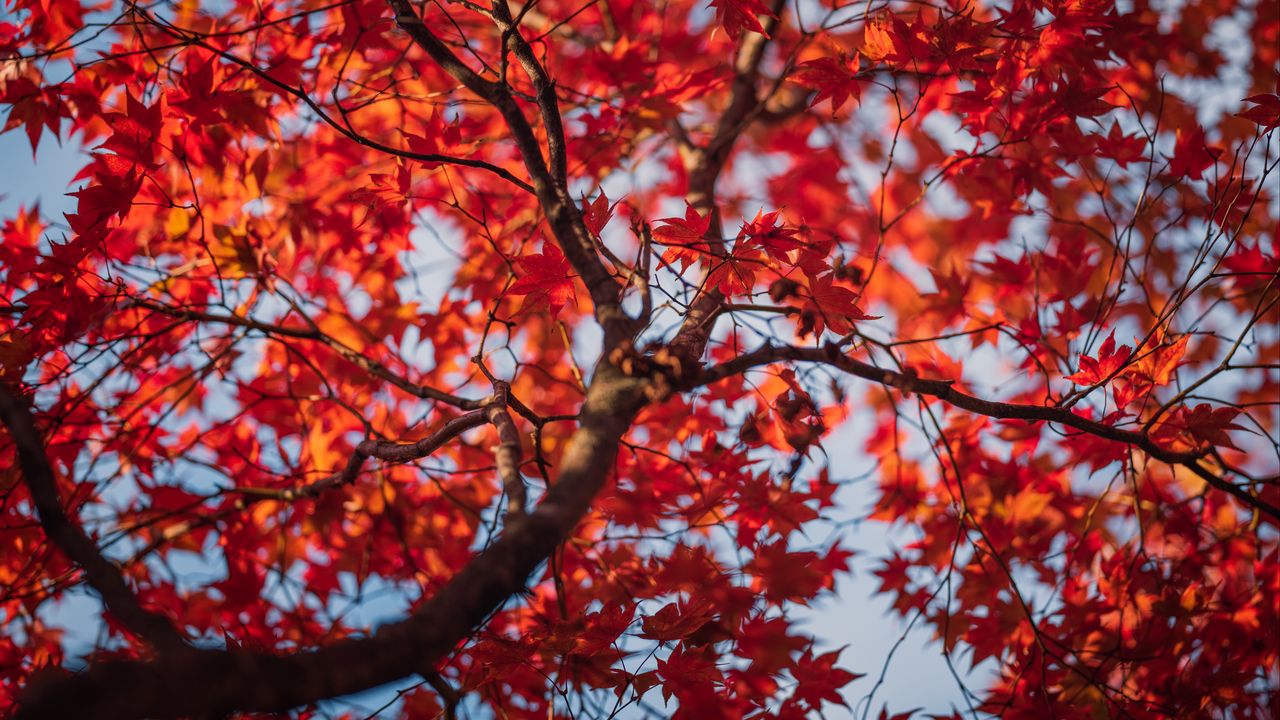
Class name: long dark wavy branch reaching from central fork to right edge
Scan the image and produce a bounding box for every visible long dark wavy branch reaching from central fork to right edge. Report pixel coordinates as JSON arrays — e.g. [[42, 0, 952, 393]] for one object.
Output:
[[685, 345, 1280, 521]]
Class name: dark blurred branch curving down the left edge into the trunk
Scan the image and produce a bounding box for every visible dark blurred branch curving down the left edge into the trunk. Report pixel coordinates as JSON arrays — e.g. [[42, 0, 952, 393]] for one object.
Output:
[[0, 387, 191, 657]]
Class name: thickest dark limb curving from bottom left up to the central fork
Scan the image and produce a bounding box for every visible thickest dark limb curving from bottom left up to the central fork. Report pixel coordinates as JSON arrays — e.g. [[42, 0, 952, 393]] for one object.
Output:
[[15, 364, 645, 720]]
